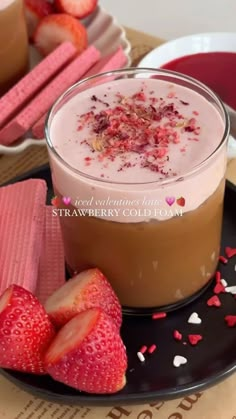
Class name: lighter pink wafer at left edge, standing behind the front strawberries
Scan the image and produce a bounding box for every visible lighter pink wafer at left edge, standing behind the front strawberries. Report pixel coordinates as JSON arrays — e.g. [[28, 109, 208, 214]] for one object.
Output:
[[0, 179, 46, 294]]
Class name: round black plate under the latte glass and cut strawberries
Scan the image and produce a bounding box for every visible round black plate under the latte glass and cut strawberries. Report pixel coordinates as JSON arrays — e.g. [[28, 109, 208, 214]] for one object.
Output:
[[1, 167, 236, 406]]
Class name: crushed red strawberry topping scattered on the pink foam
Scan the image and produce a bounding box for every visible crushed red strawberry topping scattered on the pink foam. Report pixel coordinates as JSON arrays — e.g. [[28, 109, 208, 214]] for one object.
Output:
[[77, 89, 200, 178]]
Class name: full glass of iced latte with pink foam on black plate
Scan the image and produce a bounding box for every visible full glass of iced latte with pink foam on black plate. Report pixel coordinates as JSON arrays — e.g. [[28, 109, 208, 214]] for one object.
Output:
[[46, 69, 228, 312]]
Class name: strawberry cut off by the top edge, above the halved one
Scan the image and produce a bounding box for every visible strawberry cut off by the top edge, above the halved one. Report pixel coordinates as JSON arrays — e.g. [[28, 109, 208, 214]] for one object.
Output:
[[55, 0, 98, 19]]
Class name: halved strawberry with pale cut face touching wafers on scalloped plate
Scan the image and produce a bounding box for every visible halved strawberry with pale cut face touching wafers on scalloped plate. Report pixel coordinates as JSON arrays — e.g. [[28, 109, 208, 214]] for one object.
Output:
[[34, 14, 88, 55]]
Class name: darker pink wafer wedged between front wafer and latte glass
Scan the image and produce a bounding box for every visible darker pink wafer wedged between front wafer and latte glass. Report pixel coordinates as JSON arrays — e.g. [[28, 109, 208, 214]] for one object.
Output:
[[36, 206, 65, 304]]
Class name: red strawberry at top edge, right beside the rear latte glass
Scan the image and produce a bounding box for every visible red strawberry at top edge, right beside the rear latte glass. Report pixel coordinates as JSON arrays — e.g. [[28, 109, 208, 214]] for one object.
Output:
[[24, 0, 54, 39]]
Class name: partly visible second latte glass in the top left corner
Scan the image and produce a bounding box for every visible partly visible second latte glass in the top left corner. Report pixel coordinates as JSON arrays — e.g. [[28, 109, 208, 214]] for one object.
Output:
[[0, 0, 29, 95]]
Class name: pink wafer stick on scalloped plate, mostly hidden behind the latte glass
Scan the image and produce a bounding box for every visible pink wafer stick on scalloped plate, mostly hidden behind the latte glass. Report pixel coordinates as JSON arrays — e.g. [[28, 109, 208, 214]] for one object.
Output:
[[32, 47, 127, 139]]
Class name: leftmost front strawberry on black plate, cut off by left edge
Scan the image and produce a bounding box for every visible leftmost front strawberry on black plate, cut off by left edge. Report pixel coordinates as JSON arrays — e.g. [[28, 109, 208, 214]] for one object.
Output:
[[0, 285, 55, 374]]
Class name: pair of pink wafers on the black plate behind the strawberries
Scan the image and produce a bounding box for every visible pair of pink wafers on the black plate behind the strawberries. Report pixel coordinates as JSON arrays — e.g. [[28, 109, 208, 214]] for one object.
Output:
[[0, 179, 65, 302]]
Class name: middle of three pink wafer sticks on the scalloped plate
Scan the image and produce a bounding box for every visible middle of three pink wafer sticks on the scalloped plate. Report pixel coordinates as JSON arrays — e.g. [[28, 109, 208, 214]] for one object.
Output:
[[0, 46, 100, 145]]
